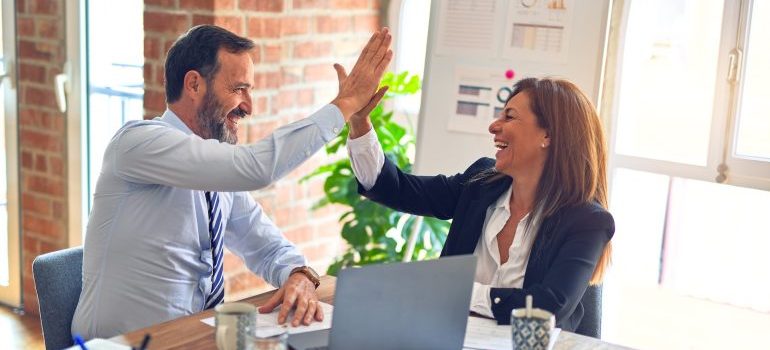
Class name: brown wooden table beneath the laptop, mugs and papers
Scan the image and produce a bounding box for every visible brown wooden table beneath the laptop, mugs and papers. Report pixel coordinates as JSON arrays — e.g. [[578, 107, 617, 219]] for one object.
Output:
[[110, 276, 628, 350]]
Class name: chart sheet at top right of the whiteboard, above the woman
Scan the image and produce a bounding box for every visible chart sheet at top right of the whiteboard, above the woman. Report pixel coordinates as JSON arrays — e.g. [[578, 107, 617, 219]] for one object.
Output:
[[501, 0, 578, 63]]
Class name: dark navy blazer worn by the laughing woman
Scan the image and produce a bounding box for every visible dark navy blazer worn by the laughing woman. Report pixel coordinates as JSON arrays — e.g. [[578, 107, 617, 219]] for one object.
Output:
[[358, 157, 615, 331]]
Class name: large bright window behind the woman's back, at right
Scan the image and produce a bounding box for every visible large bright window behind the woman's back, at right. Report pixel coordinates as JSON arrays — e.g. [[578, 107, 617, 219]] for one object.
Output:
[[602, 0, 770, 349]]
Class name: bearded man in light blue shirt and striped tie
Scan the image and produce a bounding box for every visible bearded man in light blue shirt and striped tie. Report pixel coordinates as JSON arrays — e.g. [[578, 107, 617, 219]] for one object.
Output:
[[72, 25, 392, 338]]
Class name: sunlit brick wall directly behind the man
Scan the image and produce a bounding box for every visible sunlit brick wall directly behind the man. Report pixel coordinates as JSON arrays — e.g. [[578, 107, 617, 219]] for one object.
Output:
[[144, 0, 380, 300]]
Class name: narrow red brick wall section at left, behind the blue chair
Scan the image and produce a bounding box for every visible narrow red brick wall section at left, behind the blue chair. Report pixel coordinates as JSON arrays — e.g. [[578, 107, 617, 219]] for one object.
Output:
[[16, 0, 67, 313]]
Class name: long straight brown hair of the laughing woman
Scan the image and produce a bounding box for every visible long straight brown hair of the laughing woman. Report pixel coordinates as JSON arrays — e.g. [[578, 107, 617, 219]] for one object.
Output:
[[474, 78, 612, 285]]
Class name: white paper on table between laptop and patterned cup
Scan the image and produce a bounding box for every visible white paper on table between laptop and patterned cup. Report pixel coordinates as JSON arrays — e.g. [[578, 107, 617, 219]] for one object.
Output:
[[463, 316, 561, 350]]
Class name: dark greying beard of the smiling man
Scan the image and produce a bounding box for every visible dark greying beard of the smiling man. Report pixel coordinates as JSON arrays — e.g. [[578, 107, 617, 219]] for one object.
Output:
[[197, 90, 246, 145]]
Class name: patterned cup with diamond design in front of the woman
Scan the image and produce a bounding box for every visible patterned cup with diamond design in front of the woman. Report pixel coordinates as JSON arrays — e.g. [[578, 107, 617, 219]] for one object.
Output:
[[511, 308, 556, 350]]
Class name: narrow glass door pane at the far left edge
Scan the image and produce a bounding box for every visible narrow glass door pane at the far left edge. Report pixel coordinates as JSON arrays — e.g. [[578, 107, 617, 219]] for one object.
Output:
[[0, 1, 21, 307]]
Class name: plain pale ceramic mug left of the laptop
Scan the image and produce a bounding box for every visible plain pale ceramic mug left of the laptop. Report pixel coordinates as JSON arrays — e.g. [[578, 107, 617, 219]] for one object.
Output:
[[214, 303, 257, 350]]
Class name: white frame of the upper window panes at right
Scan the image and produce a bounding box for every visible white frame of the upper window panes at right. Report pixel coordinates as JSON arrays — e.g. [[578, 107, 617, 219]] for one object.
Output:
[[600, 0, 770, 190]]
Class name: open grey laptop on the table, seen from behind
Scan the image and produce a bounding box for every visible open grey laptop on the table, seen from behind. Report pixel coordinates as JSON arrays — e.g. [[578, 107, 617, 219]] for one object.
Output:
[[289, 255, 476, 350]]
